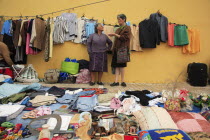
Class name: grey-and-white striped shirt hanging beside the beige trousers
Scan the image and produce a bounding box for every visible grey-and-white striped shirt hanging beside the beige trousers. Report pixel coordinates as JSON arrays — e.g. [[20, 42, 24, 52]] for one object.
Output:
[[53, 16, 68, 44]]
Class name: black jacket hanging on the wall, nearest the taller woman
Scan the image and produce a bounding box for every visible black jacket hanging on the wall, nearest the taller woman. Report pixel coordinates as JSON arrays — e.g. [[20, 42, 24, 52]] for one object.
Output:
[[139, 19, 160, 48]]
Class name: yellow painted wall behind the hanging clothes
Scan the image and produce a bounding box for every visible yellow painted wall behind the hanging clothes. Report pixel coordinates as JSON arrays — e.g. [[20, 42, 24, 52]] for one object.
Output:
[[0, 0, 210, 83]]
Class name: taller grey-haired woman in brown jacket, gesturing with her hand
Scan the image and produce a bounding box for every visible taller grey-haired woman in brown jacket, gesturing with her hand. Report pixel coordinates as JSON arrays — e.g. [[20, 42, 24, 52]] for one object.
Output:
[[109, 14, 131, 87]]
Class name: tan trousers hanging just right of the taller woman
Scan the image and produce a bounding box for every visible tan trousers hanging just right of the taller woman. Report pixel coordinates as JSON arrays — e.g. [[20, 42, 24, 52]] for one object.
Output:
[[130, 25, 143, 51]]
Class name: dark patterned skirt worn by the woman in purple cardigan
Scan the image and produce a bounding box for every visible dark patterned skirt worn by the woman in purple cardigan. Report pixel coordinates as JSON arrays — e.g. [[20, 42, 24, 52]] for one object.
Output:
[[89, 52, 108, 72]]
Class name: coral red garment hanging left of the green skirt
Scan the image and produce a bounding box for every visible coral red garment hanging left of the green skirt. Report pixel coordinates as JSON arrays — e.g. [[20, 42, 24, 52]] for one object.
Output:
[[168, 23, 179, 47]]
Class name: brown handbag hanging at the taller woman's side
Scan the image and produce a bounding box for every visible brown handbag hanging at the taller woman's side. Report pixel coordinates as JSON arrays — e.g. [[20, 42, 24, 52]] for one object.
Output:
[[117, 46, 130, 63]]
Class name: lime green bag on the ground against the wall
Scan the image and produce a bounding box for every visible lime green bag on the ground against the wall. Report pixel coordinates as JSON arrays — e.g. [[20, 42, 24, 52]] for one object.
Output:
[[61, 61, 79, 74]]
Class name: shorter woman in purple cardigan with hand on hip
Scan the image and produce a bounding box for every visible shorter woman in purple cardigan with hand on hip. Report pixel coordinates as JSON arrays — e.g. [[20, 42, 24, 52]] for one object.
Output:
[[87, 23, 112, 86]]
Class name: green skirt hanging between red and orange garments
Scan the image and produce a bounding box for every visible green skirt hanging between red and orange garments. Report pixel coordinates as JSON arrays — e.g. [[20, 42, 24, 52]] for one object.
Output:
[[174, 25, 189, 46]]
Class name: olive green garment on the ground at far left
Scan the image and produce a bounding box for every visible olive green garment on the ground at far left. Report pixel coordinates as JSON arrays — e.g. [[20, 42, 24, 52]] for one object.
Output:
[[0, 93, 26, 104]]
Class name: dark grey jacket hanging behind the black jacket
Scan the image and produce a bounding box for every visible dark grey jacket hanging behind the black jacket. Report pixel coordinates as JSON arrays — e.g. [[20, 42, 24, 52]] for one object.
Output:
[[150, 13, 168, 42]]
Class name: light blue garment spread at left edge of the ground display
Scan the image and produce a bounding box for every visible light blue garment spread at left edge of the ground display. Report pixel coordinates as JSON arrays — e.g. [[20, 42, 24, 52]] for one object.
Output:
[[0, 83, 41, 98]]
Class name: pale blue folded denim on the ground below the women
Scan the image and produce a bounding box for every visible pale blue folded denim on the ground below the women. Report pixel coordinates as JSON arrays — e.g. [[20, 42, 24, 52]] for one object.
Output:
[[77, 95, 98, 111]]
